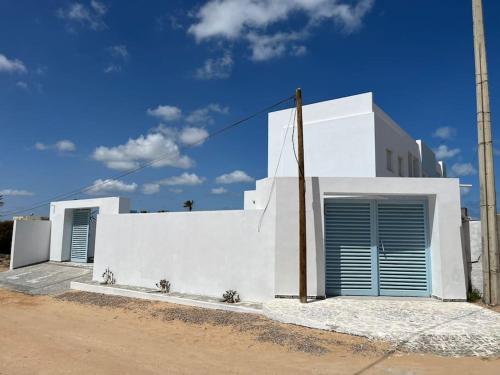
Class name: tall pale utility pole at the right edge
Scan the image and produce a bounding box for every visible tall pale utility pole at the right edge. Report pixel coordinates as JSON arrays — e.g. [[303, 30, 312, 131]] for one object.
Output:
[[472, 0, 500, 305]]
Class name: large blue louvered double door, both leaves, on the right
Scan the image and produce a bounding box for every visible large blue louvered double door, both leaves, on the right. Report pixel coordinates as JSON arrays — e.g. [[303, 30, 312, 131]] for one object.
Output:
[[325, 199, 430, 296]]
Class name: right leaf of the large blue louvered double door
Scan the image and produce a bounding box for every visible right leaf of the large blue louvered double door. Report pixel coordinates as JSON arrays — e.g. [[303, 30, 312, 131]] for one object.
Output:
[[377, 201, 430, 296]]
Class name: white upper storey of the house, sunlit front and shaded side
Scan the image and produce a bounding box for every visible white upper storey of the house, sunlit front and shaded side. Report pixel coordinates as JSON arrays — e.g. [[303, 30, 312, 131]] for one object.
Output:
[[268, 93, 442, 181]]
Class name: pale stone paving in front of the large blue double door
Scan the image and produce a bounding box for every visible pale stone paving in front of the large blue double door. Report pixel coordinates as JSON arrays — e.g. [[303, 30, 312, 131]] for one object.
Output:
[[264, 297, 500, 356]]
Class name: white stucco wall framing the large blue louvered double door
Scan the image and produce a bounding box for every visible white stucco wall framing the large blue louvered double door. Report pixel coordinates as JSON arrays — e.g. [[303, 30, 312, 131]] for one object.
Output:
[[264, 177, 466, 300]]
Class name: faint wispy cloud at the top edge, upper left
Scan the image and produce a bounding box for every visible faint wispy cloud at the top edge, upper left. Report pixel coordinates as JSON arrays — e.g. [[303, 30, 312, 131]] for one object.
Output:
[[57, 0, 108, 30]]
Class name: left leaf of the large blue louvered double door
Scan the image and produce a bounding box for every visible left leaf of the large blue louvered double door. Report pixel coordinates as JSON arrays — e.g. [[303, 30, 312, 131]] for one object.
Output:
[[325, 199, 378, 295]]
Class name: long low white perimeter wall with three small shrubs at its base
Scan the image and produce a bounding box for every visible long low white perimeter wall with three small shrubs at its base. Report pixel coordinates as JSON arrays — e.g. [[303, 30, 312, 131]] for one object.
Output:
[[94, 209, 275, 301]]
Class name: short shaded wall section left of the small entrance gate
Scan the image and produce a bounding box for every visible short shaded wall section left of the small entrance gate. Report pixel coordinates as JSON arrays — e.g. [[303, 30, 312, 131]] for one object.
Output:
[[10, 220, 50, 270]]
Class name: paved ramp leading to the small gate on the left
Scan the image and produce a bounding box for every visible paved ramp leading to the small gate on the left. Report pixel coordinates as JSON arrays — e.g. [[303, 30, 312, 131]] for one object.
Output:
[[0, 262, 92, 295]]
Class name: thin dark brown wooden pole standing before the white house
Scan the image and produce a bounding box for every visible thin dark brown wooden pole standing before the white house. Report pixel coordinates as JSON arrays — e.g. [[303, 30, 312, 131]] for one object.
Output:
[[295, 89, 307, 303]]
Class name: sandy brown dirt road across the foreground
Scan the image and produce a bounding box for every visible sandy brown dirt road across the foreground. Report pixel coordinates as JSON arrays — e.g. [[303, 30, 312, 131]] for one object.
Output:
[[0, 289, 500, 375]]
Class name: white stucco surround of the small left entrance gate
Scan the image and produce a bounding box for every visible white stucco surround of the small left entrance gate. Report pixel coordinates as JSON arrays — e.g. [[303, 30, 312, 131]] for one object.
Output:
[[50, 197, 130, 262]]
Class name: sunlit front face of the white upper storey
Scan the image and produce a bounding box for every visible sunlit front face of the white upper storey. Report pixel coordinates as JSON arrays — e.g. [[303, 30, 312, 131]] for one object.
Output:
[[268, 93, 375, 177]]
